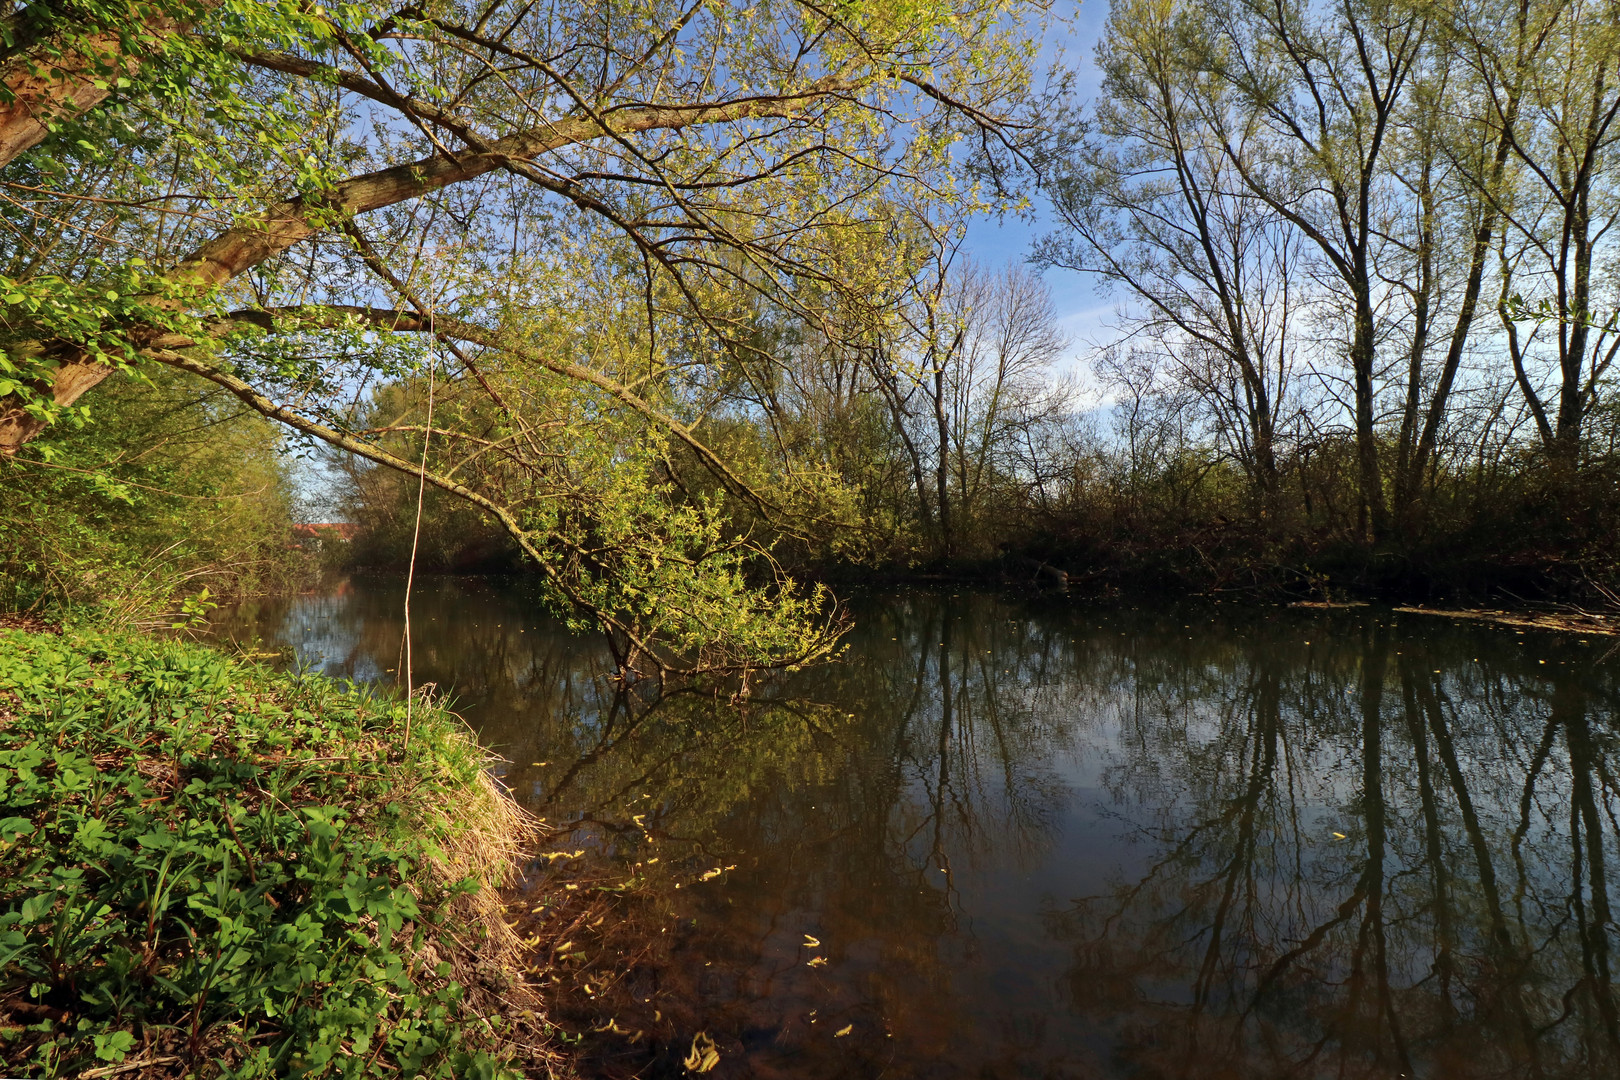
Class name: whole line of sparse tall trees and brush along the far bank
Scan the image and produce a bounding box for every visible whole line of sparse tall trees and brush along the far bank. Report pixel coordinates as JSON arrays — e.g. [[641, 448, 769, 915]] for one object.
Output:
[[322, 0, 1620, 602]]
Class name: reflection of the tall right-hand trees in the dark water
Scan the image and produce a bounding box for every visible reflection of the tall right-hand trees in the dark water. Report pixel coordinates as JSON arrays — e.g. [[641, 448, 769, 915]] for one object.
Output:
[[1051, 619, 1620, 1077]]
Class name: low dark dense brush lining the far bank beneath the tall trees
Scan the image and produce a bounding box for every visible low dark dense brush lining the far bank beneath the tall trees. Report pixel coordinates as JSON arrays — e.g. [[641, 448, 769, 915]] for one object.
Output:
[[328, 418, 1620, 607]]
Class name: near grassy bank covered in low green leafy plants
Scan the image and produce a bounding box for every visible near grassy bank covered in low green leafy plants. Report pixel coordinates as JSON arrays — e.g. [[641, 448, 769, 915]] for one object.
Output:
[[0, 630, 551, 1077]]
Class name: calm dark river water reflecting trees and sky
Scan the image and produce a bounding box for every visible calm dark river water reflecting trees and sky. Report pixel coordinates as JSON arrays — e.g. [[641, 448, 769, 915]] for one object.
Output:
[[222, 580, 1620, 1078]]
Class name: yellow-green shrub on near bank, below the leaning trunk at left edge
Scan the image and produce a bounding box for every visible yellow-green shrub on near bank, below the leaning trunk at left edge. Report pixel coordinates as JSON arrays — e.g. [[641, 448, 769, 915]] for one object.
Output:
[[0, 371, 292, 623]]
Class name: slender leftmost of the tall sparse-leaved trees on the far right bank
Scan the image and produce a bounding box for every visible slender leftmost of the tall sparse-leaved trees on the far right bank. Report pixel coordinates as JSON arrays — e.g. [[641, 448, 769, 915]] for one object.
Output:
[[1038, 3, 1306, 512]]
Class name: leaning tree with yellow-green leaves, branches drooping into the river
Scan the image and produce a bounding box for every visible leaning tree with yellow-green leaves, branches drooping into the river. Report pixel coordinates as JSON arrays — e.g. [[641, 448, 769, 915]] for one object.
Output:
[[0, 0, 1029, 670]]
